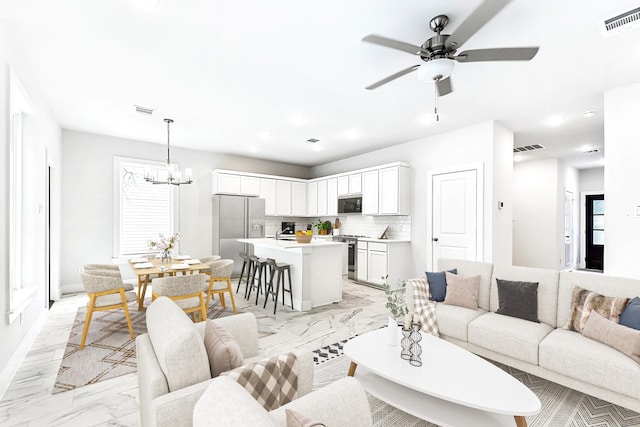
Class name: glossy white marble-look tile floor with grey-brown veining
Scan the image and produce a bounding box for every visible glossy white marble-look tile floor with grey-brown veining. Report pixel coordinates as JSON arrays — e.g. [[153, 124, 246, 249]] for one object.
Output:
[[0, 279, 387, 427]]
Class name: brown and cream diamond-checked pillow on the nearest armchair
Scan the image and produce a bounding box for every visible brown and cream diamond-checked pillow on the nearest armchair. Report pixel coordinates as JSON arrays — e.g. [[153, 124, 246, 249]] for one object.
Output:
[[220, 353, 298, 411]]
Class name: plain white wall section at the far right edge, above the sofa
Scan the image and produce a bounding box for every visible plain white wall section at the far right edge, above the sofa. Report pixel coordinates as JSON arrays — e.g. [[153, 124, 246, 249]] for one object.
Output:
[[604, 83, 640, 278]]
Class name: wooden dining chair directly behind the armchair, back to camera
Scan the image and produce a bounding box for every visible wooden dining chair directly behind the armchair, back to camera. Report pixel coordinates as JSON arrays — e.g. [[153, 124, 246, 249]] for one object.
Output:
[[151, 274, 207, 322]]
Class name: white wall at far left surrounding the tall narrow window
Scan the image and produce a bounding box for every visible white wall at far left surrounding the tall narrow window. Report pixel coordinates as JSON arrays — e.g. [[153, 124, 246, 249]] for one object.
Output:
[[0, 25, 60, 369]]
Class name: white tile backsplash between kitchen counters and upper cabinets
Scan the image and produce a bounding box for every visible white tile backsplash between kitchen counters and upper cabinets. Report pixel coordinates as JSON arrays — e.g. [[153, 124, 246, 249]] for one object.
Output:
[[265, 215, 411, 240]]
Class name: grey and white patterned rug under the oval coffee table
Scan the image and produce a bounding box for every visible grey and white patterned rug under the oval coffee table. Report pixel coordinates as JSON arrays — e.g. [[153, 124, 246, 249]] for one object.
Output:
[[314, 341, 640, 427]]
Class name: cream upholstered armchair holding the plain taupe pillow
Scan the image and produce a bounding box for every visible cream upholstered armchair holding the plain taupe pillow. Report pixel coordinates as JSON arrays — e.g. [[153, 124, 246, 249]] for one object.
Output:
[[136, 297, 314, 427]]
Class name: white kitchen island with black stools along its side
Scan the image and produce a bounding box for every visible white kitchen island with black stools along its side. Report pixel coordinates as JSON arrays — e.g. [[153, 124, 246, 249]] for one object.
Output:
[[238, 238, 345, 311]]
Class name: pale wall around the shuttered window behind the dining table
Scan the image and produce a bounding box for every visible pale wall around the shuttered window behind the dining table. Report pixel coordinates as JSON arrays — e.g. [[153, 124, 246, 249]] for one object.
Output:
[[61, 130, 309, 293]]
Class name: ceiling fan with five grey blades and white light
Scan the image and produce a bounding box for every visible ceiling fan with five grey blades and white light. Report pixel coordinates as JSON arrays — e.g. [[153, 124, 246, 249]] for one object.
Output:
[[362, 0, 538, 99]]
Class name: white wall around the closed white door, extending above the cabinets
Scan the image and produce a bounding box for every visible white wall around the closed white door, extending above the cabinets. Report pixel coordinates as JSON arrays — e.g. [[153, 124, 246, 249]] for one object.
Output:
[[312, 122, 513, 276]]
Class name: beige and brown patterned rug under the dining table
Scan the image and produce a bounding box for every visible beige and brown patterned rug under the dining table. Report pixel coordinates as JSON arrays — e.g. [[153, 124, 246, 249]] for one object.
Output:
[[52, 298, 273, 394]]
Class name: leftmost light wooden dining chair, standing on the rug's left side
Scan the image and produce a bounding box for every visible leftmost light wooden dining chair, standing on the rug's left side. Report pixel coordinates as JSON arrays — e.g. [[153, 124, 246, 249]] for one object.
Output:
[[80, 268, 138, 350]]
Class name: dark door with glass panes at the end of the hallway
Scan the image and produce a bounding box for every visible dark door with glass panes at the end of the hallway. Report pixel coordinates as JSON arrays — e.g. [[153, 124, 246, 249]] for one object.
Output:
[[584, 194, 604, 271]]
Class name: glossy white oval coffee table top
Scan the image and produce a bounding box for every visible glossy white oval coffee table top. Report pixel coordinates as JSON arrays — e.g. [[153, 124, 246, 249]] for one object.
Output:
[[344, 328, 541, 416]]
